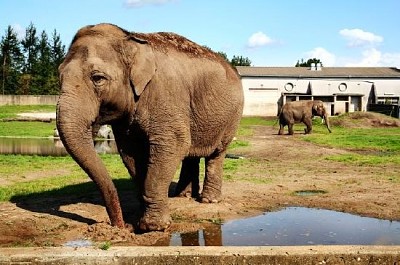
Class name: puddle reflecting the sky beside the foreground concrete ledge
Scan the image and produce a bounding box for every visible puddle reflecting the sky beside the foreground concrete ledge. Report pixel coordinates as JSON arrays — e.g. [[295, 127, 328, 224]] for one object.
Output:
[[170, 207, 400, 246]]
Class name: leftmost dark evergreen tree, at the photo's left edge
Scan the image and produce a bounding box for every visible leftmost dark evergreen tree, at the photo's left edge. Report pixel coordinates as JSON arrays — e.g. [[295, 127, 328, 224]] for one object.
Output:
[[0, 26, 24, 95]]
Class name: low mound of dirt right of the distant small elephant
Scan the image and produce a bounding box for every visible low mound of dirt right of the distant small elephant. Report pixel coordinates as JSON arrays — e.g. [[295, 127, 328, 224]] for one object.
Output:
[[330, 112, 400, 128]]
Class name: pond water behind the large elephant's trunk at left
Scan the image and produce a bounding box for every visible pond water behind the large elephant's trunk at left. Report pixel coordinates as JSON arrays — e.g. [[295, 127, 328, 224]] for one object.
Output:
[[0, 138, 117, 156]]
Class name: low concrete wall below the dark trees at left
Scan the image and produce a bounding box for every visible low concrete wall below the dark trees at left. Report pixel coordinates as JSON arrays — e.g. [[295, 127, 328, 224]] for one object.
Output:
[[0, 95, 58, 106]]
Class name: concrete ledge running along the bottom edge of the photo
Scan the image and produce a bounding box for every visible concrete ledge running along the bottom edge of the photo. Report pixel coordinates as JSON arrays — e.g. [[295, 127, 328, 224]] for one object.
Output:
[[0, 245, 400, 265]]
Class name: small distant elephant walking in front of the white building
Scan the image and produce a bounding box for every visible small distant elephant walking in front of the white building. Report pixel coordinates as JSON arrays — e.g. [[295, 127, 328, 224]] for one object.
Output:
[[278, 100, 332, 135]]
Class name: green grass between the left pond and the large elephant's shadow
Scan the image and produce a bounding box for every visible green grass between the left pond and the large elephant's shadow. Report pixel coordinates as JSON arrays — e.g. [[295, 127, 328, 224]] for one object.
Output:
[[0, 155, 130, 201]]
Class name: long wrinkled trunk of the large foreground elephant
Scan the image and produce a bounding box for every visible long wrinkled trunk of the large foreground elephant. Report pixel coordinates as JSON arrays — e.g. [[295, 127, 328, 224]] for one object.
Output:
[[57, 93, 125, 228]]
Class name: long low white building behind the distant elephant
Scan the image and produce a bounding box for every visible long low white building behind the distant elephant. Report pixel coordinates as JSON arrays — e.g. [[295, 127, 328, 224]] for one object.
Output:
[[237, 65, 400, 116]]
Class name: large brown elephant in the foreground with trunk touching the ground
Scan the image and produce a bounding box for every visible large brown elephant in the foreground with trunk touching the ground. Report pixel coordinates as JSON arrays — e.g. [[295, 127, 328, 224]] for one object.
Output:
[[57, 24, 243, 230]]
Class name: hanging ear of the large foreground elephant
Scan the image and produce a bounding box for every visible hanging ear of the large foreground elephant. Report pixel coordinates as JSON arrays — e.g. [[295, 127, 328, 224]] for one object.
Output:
[[128, 35, 156, 96]]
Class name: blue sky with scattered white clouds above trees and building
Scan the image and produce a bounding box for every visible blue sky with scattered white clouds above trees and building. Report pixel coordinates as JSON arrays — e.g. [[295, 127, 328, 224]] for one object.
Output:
[[0, 0, 400, 68]]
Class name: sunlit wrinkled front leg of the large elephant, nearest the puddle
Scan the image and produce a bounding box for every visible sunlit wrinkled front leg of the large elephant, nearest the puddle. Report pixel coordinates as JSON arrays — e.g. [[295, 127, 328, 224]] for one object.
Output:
[[139, 154, 180, 231]]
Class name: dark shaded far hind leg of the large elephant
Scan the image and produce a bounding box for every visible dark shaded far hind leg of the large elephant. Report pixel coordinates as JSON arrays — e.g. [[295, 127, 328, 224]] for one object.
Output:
[[174, 157, 200, 198]]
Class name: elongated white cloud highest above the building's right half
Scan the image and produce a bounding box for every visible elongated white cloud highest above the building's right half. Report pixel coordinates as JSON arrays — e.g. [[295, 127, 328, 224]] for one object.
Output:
[[339, 29, 383, 47]]
